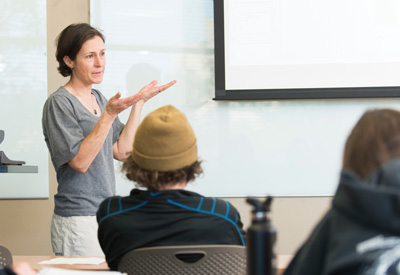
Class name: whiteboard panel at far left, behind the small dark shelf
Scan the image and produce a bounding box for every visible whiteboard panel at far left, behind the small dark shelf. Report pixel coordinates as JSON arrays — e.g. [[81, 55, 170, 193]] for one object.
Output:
[[0, 0, 49, 199]]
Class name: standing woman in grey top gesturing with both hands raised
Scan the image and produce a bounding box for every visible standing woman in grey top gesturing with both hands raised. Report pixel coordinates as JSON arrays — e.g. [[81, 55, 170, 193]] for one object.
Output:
[[42, 23, 175, 256]]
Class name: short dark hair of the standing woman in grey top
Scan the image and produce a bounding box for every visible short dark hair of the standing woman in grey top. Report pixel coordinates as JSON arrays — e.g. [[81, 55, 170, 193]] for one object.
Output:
[[56, 23, 105, 76]]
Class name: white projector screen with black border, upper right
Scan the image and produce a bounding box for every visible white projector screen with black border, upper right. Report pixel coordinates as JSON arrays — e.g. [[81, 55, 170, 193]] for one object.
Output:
[[214, 0, 400, 100]]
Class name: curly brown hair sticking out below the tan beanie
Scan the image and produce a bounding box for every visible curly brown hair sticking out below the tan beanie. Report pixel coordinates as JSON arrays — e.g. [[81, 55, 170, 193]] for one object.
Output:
[[122, 156, 203, 191]]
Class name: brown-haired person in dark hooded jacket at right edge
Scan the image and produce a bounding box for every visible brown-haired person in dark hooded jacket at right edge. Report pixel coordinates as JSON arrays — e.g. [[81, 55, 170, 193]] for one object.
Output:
[[284, 109, 400, 275]]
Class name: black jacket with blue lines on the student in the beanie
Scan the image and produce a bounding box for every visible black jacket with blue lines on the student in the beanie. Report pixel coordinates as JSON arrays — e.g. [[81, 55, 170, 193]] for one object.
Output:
[[97, 189, 245, 270]]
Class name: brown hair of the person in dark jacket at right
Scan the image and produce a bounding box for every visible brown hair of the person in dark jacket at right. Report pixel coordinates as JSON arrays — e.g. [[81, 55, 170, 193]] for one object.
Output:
[[343, 109, 400, 178]]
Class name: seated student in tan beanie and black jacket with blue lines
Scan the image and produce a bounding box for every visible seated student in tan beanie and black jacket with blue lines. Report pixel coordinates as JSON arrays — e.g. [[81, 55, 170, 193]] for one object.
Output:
[[97, 105, 245, 270]]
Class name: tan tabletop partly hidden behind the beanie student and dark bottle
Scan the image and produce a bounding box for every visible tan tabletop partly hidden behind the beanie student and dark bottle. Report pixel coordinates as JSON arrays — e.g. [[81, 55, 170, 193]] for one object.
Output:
[[13, 255, 293, 275]]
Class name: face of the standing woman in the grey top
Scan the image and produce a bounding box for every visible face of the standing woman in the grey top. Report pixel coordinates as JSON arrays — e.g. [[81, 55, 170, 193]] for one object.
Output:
[[71, 36, 106, 86]]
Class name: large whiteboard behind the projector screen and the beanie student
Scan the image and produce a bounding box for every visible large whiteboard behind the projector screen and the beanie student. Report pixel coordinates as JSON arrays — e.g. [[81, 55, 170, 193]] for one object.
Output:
[[90, 0, 400, 197]]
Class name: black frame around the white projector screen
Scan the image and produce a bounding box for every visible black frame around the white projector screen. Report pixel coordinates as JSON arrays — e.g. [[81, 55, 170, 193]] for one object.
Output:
[[213, 0, 400, 101]]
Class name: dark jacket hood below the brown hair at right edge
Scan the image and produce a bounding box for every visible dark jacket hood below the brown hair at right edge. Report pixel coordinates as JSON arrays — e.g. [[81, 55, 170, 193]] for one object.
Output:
[[332, 159, 400, 235]]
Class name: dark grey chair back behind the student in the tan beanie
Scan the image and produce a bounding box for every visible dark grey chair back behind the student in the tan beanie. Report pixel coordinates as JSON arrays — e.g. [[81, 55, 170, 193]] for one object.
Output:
[[118, 245, 247, 275]]
